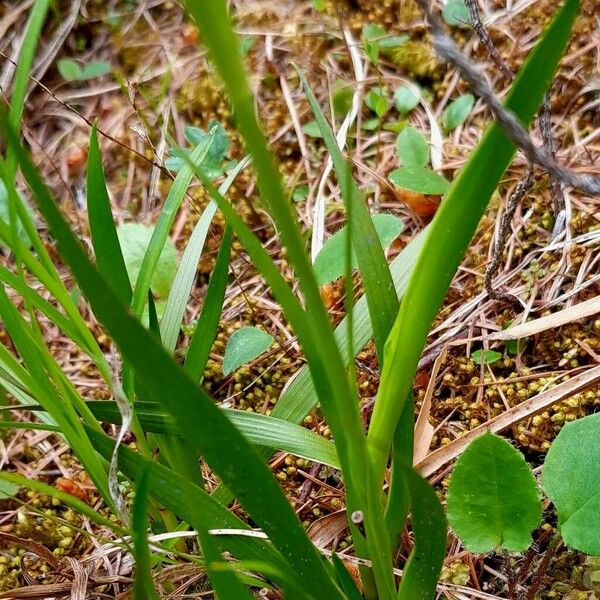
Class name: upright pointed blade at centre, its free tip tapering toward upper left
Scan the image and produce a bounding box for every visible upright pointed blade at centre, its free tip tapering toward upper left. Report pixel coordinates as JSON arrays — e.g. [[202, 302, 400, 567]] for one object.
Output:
[[296, 68, 399, 365]]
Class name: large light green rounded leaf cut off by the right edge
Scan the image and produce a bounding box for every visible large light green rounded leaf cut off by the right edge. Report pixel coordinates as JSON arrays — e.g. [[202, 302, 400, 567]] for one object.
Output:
[[542, 413, 600, 556]]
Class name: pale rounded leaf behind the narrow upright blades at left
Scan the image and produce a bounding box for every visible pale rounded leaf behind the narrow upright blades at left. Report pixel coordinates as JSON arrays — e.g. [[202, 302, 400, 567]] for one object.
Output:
[[117, 223, 177, 298]]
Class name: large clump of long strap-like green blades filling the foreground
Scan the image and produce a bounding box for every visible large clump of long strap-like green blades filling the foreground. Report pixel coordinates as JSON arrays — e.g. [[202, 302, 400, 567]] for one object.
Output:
[[0, 0, 578, 600]]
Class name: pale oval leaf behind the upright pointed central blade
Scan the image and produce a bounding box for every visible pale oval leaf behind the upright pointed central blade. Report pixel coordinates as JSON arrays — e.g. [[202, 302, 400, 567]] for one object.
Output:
[[314, 214, 404, 285]]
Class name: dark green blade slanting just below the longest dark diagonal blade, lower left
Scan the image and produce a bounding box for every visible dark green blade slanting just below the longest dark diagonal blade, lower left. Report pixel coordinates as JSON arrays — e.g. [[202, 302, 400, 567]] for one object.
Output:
[[89, 430, 301, 582]]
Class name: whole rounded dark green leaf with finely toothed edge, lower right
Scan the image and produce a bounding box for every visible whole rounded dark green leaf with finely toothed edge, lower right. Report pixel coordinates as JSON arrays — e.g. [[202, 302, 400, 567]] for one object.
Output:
[[447, 433, 542, 553]]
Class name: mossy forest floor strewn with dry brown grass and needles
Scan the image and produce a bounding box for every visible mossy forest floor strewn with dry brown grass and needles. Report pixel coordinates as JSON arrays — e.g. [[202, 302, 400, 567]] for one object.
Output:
[[0, 0, 600, 600]]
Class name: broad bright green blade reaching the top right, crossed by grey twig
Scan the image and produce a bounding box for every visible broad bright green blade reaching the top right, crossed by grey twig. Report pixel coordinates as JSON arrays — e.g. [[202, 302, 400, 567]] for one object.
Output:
[[368, 0, 579, 481]]
